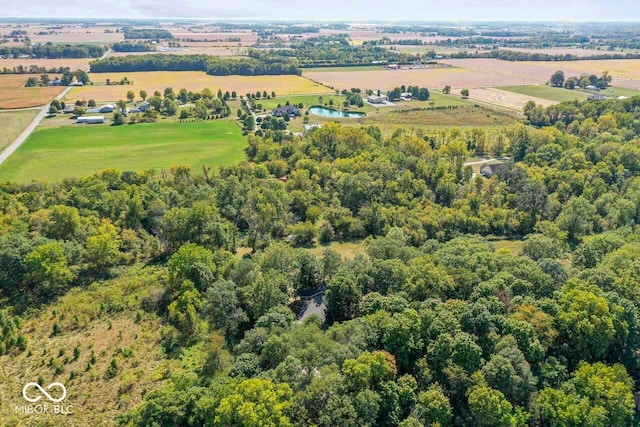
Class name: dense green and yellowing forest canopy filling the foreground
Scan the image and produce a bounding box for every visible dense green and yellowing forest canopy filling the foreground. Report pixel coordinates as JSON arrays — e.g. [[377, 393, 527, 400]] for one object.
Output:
[[0, 90, 640, 427]]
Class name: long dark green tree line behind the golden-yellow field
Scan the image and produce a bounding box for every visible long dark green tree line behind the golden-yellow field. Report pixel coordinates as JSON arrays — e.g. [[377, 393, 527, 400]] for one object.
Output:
[[89, 54, 301, 76]]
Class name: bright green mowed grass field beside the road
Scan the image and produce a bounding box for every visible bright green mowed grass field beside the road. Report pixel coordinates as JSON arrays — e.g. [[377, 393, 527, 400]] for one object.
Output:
[[0, 121, 245, 182]]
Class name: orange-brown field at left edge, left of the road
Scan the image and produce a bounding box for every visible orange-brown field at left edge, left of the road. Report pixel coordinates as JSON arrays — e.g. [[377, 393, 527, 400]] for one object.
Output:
[[0, 74, 64, 109]]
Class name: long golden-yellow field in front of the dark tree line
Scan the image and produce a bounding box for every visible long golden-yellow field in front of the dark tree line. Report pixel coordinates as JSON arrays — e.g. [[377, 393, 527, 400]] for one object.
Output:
[[67, 71, 332, 102]]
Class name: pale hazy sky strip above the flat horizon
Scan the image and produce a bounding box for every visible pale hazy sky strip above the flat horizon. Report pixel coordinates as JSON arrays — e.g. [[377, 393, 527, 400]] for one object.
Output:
[[0, 0, 640, 22]]
